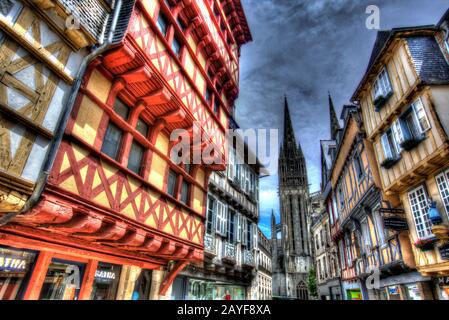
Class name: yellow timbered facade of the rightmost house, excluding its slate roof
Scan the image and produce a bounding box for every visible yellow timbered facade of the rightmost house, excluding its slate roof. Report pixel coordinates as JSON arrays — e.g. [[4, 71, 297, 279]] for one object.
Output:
[[355, 29, 449, 288]]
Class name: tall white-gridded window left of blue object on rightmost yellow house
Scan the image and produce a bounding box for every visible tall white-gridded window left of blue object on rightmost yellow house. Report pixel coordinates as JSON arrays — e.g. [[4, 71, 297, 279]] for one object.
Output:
[[408, 186, 431, 238]]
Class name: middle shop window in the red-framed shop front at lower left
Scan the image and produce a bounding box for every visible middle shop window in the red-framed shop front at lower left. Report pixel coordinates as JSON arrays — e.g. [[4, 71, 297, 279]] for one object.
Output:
[[39, 259, 85, 300]]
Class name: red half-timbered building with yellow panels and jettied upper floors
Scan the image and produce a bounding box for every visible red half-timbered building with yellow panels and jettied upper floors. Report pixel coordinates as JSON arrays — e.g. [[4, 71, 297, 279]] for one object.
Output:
[[0, 0, 251, 299]]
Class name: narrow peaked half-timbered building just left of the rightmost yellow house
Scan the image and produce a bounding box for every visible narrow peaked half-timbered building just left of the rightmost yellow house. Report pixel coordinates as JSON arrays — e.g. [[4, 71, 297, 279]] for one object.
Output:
[[329, 105, 428, 300]]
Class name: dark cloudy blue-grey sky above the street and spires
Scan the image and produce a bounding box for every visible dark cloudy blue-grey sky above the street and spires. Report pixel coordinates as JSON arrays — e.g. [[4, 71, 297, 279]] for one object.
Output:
[[236, 0, 449, 236]]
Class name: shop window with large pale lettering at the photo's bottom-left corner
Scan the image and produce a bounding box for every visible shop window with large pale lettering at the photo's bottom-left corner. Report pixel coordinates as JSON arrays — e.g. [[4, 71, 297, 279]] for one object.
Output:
[[0, 247, 36, 300]]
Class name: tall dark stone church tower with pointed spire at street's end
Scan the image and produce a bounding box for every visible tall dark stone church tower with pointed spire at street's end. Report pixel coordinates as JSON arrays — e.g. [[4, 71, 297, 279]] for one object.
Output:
[[272, 98, 312, 300]]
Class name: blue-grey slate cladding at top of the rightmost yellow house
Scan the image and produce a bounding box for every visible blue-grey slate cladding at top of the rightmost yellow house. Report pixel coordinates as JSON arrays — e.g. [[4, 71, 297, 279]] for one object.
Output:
[[406, 37, 449, 84]]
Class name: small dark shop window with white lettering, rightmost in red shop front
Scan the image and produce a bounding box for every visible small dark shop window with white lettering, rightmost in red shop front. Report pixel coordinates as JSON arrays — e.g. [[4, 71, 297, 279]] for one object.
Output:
[[90, 262, 121, 300]]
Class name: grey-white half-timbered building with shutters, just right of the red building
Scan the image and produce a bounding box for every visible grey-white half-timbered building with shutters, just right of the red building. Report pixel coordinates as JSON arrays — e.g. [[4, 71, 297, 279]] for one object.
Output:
[[173, 128, 262, 300]]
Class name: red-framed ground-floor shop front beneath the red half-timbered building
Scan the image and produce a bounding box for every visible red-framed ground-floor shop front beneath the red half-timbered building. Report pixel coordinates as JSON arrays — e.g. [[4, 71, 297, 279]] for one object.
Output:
[[0, 236, 159, 300]]
